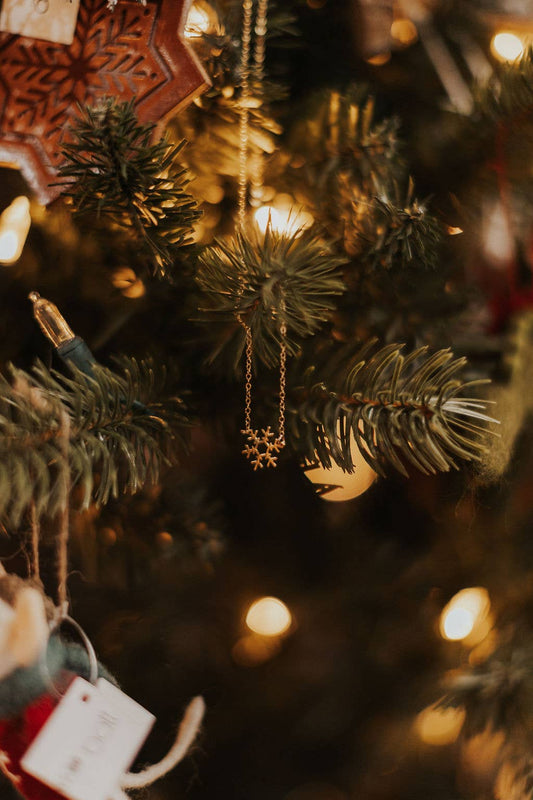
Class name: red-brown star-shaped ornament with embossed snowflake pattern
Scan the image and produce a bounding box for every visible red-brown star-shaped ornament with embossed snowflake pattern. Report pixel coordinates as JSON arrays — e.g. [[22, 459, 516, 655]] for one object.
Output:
[[0, 0, 208, 203]]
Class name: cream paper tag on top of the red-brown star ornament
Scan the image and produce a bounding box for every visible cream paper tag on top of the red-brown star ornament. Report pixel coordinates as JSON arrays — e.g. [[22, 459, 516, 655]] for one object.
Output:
[[0, 0, 80, 44]]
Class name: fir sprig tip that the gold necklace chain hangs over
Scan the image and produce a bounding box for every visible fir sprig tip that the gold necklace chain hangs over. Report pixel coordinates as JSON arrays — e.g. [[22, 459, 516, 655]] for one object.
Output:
[[197, 226, 345, 366]]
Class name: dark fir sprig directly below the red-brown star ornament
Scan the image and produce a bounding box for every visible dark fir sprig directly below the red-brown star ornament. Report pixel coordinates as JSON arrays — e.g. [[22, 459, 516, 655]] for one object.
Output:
[[60, 100, 200, 277]]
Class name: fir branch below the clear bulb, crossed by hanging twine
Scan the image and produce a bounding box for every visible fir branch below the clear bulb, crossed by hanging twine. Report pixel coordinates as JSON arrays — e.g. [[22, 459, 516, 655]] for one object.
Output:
[[0, 359, 185, 526]]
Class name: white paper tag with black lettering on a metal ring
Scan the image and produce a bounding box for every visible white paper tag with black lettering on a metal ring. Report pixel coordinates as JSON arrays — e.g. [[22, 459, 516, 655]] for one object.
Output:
[[20, 678, 155, 800]]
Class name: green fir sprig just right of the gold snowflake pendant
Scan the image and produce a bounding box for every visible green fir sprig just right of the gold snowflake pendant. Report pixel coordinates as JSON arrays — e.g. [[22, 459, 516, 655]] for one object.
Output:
[[289, 341, 490, 476]]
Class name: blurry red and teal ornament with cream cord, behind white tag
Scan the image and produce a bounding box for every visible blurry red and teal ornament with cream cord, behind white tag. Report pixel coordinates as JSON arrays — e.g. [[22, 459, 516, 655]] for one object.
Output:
[[0, 563, 205, 800]]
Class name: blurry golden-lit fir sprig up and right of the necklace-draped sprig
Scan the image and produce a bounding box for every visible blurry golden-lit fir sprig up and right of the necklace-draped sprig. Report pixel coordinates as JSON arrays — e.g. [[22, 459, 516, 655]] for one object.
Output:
[[284, 86, 442, 270]]
